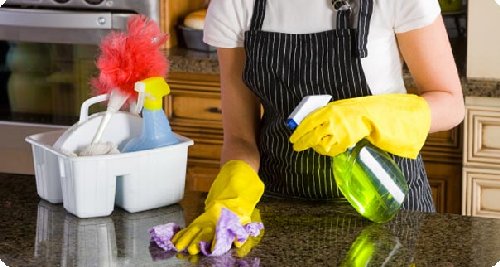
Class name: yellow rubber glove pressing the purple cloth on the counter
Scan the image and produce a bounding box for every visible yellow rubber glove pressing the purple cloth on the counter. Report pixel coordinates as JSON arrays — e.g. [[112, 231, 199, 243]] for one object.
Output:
[[172, 160, 264, 255]]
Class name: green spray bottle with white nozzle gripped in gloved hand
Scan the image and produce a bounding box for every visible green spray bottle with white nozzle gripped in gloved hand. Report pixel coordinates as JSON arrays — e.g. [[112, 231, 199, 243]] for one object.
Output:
[[287, 95, 408, 223]]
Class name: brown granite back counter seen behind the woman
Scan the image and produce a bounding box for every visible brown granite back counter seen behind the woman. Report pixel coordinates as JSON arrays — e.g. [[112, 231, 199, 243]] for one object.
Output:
[[167, 48, 500, 97]]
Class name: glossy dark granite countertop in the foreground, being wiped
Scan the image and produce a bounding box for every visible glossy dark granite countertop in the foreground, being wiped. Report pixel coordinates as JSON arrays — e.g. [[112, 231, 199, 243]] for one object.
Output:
[[0, 173, 500, 267]]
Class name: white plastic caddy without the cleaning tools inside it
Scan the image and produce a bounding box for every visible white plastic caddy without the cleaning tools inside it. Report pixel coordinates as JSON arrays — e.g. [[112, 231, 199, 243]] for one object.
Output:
[[26, 94, 193, 218]]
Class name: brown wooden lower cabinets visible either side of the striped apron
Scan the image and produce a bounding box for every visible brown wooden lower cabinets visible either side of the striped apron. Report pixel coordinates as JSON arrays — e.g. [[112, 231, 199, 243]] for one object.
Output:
[[165, 72, 462, 216]]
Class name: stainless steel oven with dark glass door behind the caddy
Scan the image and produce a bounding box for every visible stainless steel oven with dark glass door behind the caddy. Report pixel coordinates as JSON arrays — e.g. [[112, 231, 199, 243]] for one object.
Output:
[[0, 0, 161, 174]]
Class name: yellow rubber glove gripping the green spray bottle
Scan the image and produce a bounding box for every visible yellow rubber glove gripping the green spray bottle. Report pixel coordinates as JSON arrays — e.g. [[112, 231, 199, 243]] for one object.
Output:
[[290, 94, 431, 159]]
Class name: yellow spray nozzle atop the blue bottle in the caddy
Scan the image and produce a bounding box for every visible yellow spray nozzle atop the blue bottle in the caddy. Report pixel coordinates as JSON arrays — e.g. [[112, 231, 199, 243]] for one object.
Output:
[[135, 77, 170, 110]]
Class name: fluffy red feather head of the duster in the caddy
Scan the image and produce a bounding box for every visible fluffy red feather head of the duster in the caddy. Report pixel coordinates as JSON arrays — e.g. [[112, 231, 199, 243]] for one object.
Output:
[[91, 15, 169, 101]]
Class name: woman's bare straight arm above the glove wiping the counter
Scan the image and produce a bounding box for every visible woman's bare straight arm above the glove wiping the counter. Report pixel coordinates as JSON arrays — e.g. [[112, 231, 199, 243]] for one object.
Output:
[[217, 48, 260, 171]]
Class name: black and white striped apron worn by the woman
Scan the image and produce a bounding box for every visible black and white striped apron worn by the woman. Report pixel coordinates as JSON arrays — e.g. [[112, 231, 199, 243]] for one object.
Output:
[[243, 0, 434, 214]]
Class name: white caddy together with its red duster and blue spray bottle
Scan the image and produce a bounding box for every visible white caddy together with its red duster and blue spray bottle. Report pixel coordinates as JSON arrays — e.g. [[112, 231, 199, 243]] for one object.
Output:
[[26, 15, 193, 218]]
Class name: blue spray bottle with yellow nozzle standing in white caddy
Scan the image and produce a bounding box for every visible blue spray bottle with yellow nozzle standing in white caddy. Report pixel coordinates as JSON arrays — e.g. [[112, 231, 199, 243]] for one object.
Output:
[[122, 77, 180, 152]]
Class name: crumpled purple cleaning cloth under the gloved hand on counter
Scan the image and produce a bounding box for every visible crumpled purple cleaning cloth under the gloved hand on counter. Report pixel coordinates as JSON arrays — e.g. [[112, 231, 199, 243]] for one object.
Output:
[[149, 209, 264, 256]]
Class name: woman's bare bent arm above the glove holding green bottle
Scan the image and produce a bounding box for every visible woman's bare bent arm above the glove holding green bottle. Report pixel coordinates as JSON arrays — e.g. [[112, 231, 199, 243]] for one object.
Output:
[[396, 16, 465, 133]]
